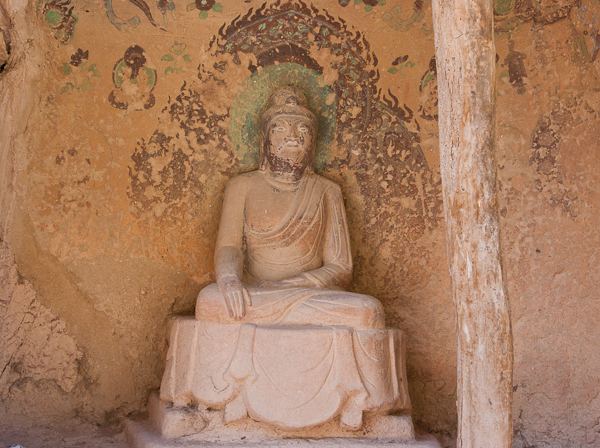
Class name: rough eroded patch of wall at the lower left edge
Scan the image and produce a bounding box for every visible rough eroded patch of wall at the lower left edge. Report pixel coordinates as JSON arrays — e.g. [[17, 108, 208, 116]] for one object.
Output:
[[0, 245, 83, 424]]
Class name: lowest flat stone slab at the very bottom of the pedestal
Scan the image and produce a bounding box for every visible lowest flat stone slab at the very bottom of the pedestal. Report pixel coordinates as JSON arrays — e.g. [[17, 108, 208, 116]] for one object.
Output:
[[125, 421, 440, 448]]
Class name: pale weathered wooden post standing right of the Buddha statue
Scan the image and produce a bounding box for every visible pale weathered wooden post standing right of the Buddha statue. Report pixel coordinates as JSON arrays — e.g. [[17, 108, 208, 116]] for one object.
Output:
[[433, 0, 513, 448]]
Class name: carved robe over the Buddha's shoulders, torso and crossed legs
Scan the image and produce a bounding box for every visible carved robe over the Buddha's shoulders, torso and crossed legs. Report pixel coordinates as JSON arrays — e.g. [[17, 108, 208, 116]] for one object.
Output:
[[196, 171, 384, 329]]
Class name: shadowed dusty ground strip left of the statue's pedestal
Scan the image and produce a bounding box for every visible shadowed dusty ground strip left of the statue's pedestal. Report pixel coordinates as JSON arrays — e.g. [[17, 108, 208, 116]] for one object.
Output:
[[0, 419, 129, 448]]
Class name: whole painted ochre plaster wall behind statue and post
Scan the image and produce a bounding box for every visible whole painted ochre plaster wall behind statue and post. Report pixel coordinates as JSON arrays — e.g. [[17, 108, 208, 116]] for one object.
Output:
[[0, 0, 600, 447]]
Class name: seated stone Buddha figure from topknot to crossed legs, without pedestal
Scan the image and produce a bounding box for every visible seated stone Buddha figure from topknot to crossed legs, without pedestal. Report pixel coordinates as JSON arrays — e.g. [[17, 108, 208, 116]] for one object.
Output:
[[196, 86, 385, 329]]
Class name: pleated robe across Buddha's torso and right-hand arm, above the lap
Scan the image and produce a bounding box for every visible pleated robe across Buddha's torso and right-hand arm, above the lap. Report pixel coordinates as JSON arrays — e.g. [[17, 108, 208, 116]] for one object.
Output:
[[241, 173, 352, 289]]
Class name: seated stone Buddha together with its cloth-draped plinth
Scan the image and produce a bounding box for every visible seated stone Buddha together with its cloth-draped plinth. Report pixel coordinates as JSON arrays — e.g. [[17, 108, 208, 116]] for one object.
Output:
[[151, 86, 412, 437]]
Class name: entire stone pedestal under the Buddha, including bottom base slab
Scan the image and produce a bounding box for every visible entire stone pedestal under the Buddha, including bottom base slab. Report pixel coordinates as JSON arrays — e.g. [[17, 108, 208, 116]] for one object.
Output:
[[127, 317, 439, 448]]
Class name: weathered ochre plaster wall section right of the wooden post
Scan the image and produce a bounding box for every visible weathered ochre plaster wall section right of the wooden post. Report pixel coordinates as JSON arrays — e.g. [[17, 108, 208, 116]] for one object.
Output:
[[498, 1, 600, 447]]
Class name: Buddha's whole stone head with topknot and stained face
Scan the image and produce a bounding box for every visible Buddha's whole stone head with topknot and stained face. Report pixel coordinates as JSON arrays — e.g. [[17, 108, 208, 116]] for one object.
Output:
[[259, 86, 317, 179]]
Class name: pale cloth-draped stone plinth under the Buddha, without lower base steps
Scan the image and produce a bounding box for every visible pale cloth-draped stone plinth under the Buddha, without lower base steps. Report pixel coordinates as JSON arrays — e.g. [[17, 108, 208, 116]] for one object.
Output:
[[160, 317, 410, 434]]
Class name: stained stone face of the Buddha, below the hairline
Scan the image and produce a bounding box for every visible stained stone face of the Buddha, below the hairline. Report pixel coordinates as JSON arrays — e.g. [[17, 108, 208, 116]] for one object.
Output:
[[266, 115, 316, 178]]
